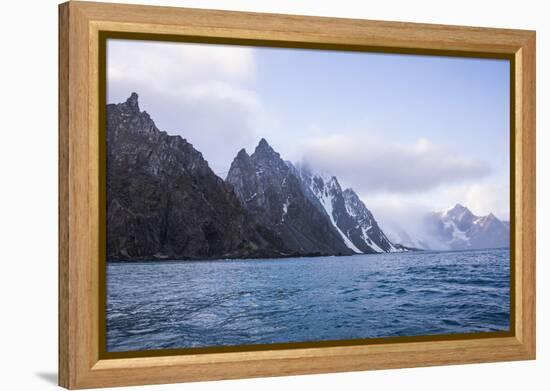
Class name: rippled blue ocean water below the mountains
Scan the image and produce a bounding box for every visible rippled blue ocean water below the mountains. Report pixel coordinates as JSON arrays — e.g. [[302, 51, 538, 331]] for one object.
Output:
[[107, 249, 510, 351]]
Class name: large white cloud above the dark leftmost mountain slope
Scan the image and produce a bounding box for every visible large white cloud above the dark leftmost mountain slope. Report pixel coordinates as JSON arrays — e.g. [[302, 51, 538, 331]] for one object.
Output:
[[107, 40, 265, 176]]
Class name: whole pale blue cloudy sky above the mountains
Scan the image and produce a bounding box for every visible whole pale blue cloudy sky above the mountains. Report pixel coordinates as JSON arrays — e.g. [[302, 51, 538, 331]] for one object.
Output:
[[107, 39, 510, 229]]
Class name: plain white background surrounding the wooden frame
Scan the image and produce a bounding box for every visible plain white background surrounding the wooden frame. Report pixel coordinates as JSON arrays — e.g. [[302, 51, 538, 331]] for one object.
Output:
[[0, 0, 550, 391]]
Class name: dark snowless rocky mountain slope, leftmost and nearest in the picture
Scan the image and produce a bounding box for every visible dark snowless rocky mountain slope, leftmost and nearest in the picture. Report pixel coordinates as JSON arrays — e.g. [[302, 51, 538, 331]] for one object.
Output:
[[107, 93, 290, 260]]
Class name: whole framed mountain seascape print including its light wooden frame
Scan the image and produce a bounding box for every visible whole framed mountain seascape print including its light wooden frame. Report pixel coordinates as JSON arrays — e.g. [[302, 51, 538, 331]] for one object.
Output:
[[59, 2, 535, 388]]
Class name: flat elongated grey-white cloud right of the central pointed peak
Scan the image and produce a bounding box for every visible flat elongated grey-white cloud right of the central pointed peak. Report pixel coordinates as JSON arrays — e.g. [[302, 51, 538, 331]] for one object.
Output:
[[304, 134, 491, 194]]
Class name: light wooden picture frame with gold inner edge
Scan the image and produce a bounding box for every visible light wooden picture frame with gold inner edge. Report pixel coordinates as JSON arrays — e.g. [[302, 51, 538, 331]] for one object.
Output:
[[59, 1, 536, 389]]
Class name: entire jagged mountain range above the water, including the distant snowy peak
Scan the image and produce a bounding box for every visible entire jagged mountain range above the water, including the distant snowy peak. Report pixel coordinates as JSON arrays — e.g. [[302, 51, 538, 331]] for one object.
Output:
[[107, 93, 509, 260]]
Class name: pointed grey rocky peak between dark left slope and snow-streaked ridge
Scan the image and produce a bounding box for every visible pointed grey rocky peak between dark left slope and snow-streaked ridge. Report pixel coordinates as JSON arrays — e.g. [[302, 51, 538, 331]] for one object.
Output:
[[226, 139, 354, 255]]
